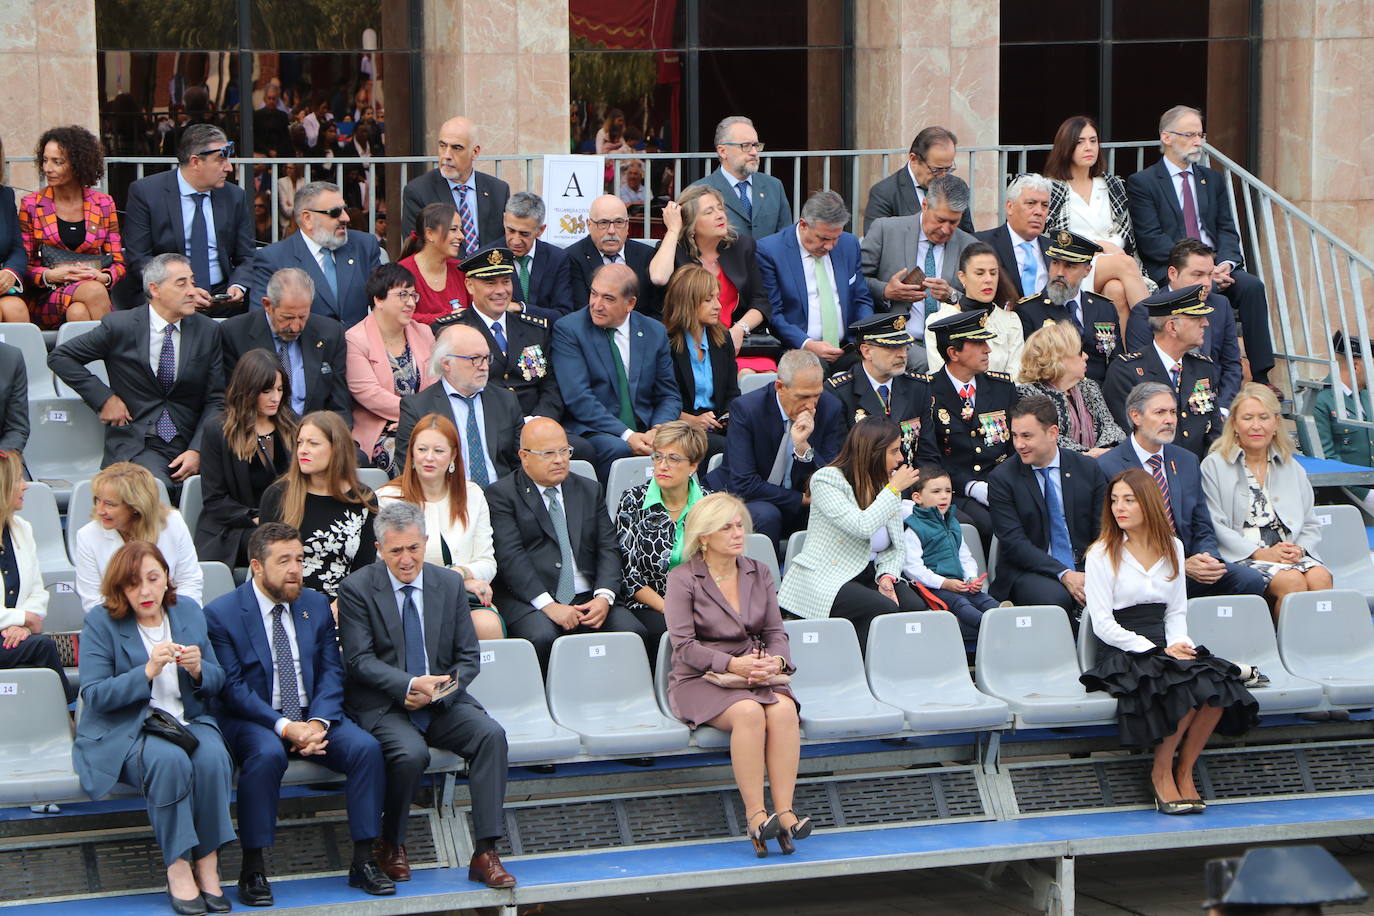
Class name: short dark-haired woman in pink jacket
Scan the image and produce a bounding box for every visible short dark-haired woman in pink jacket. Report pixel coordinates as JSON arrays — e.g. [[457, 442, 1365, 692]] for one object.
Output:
[[344, 264, 434, 477]]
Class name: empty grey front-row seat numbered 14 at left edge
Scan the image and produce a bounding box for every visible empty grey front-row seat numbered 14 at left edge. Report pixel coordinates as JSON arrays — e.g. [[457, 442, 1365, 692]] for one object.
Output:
[[0, 667, 81, 805]]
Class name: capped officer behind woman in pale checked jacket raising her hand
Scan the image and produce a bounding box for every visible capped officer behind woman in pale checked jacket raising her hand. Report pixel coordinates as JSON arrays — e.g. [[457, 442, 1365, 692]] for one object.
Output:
[[826, 314, 930, 464]]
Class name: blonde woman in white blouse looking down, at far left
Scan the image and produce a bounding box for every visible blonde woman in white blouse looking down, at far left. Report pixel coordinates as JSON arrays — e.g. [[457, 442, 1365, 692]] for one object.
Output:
[[73, 461, 203, 611]]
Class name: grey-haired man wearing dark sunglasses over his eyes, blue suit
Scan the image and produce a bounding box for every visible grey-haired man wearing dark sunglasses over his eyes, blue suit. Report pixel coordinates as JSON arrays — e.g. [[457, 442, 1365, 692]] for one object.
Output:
[[250, 181, 382, 331]]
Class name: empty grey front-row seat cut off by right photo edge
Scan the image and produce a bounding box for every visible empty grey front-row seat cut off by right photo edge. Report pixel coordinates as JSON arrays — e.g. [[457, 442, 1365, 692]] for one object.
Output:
[[1279, 589, 1374, 709]]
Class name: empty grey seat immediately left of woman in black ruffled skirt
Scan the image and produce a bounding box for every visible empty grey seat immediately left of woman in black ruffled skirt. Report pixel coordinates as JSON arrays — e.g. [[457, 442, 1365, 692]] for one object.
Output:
[[974, 604, 1116, 728]]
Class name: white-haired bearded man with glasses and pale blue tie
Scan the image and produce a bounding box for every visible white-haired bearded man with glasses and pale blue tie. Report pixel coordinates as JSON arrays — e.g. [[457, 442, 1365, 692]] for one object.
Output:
[[396, 324, 525, 489]]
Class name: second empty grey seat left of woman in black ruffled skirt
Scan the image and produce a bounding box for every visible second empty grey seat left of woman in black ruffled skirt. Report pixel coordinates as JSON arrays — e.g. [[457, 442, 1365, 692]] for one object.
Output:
[[867, 611, 1011, 732]]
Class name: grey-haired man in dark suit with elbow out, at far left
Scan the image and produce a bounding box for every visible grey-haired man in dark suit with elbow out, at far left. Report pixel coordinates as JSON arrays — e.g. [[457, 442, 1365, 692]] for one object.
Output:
[[48, 254, 224, 496]]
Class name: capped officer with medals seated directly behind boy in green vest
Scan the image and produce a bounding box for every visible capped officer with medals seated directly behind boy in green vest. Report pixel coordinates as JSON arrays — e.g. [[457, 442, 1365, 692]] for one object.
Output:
[[919, 309, 1020, 551]]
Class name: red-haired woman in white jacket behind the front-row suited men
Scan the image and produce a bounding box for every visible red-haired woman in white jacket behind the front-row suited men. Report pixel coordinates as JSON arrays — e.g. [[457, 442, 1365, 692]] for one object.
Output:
[[376, 413, 506, 640]]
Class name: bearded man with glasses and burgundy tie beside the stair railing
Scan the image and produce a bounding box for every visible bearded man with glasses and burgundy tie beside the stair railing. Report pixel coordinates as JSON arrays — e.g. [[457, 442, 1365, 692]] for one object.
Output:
[[1125, 104, 1274, 385]]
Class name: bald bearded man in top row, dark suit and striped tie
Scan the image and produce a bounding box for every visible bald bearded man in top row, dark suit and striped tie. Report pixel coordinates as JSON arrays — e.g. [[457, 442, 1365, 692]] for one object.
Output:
[[401, 117, 511, 257]]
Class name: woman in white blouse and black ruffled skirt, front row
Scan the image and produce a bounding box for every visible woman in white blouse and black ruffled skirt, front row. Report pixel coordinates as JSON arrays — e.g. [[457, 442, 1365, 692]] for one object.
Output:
[[1080, 468, 1257, 814]]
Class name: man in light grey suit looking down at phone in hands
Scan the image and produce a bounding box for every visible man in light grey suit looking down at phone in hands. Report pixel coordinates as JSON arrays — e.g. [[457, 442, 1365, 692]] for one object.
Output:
[[863, 174, 977, 372]]
